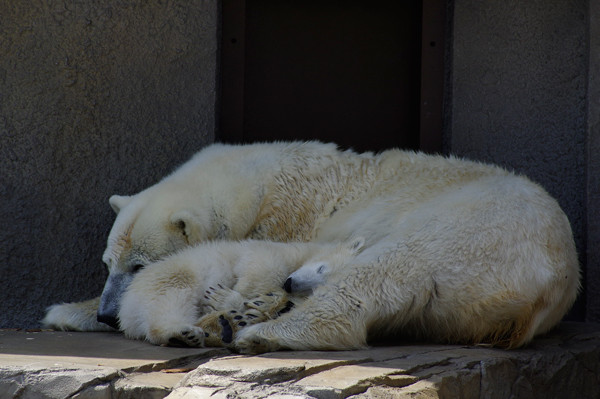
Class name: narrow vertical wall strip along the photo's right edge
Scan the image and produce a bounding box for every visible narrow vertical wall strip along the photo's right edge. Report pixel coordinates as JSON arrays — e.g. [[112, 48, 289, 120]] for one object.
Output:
[[586, 0, 600, 321]]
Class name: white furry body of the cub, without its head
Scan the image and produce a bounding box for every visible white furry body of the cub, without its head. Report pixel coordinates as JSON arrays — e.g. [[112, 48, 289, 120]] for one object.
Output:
[[119, 241, 343, 344]]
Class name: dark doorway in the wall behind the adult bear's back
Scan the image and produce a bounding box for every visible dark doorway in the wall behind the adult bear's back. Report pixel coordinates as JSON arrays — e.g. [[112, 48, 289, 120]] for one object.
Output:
[[218, 0, 443, 151]]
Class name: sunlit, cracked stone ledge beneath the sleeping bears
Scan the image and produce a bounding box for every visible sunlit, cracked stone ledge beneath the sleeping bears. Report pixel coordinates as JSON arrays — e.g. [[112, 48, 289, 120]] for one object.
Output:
[[0, 322, 600, 399]]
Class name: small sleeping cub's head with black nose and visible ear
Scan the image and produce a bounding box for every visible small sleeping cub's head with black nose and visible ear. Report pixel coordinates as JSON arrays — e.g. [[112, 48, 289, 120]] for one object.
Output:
[[283, 237, 365, 293]]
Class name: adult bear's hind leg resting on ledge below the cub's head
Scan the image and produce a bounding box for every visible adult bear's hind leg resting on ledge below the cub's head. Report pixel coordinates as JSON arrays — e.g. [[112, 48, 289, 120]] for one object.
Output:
[[234, 287, 371, 354]]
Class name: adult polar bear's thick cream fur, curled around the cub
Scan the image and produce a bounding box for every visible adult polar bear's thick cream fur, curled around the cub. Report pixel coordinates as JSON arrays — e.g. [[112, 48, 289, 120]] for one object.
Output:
[[45, 142, 579, 352]]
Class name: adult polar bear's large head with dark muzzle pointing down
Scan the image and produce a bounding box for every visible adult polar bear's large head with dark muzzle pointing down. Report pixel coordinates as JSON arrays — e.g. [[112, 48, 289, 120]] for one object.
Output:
[[97, 190, 212, 328]]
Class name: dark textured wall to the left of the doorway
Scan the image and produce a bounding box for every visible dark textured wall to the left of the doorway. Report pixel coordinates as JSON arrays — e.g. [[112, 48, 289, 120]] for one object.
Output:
[[0, 0, 218, 327]]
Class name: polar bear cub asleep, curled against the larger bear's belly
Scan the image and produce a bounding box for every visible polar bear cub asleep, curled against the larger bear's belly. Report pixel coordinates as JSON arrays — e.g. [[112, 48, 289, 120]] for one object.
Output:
[[118, 239, 363, 346]]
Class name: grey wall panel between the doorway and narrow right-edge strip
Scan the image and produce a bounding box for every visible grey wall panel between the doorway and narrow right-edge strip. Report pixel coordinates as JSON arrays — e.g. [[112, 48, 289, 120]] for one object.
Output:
[[449, 0, 588, 318]]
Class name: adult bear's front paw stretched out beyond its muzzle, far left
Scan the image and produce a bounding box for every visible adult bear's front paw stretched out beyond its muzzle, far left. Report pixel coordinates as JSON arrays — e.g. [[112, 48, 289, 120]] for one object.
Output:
[[41, 297, 114, 331]]
